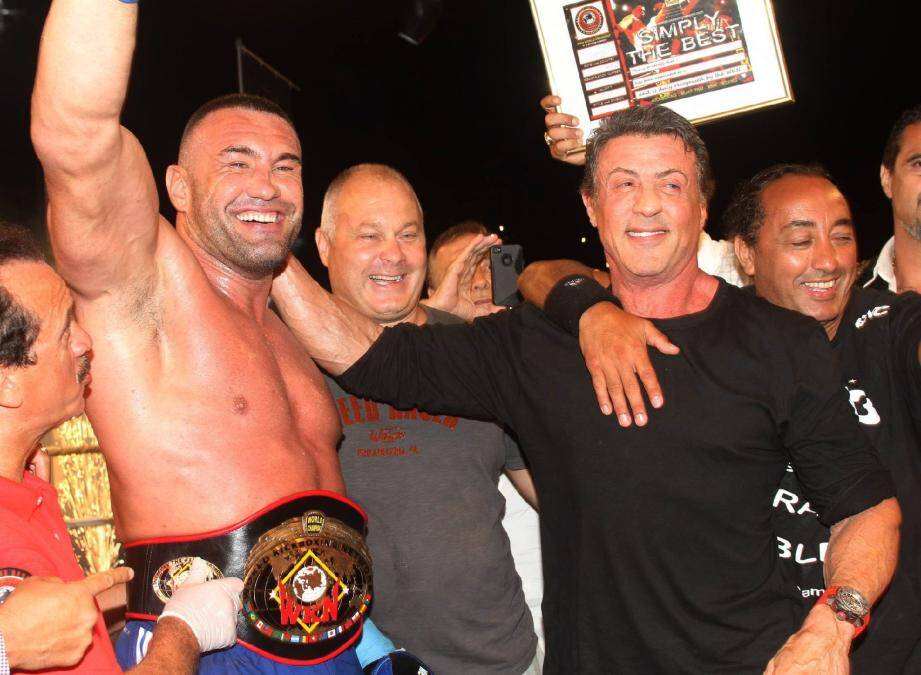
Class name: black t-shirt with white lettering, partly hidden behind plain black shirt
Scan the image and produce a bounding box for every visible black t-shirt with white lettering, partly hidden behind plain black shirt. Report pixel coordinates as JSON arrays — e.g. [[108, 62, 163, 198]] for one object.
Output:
[[774, 288, 921, 674]]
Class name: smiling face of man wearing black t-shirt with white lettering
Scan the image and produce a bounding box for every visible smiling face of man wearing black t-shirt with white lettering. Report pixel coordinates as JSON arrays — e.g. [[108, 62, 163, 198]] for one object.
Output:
[[736, 175, 857, 338]]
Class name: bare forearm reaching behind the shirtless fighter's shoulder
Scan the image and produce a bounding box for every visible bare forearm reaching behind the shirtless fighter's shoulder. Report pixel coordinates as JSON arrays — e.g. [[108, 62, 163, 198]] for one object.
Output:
[[272, 256, 381, 375]]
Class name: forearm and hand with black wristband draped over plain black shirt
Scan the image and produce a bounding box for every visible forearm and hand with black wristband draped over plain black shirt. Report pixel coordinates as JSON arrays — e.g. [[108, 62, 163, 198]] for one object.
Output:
[[518, 260, 678, 427]]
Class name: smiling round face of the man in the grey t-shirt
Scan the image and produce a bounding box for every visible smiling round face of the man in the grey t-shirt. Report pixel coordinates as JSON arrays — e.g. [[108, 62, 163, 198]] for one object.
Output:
[[316, 174, 426, 324]]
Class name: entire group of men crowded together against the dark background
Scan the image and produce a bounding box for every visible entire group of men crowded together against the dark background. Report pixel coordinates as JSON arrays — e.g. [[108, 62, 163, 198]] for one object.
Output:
[[0, 0, 921, 675]]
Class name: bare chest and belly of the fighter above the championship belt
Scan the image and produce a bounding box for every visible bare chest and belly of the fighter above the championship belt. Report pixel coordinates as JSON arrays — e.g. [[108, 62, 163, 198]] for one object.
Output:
[[77, 222, 344, 540]]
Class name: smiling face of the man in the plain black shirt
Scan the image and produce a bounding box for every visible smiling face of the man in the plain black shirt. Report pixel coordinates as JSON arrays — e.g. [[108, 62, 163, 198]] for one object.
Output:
[[582, 135, 707, 285]]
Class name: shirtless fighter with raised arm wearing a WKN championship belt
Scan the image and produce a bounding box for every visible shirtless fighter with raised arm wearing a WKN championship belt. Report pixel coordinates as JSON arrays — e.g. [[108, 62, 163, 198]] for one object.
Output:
[[32, 0, 370, 672]]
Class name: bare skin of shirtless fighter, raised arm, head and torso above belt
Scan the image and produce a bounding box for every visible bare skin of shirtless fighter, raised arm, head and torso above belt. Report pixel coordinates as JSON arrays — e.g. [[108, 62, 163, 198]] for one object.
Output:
[[32, 0, 344, 541]]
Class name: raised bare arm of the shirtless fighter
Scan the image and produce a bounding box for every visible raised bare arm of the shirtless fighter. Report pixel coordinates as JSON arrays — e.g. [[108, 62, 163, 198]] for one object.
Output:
[[31, 0, 159, 299]]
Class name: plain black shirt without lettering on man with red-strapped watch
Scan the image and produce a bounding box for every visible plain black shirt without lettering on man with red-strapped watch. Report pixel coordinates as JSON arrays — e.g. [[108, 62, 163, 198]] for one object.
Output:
[[341, 282, 892, 675]]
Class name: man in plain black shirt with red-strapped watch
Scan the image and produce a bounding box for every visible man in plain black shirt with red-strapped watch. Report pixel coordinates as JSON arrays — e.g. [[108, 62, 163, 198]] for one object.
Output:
[[273, 106, 900, 673]]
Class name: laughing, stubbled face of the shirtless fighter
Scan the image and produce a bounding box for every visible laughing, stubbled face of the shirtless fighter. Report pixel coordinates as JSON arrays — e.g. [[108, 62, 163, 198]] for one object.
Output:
[[173, 108, 304, 278]]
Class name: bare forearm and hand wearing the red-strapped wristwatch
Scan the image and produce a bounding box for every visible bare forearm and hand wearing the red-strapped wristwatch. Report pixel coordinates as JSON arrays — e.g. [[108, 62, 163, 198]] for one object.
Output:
[[765, 498, 902, 675]]
